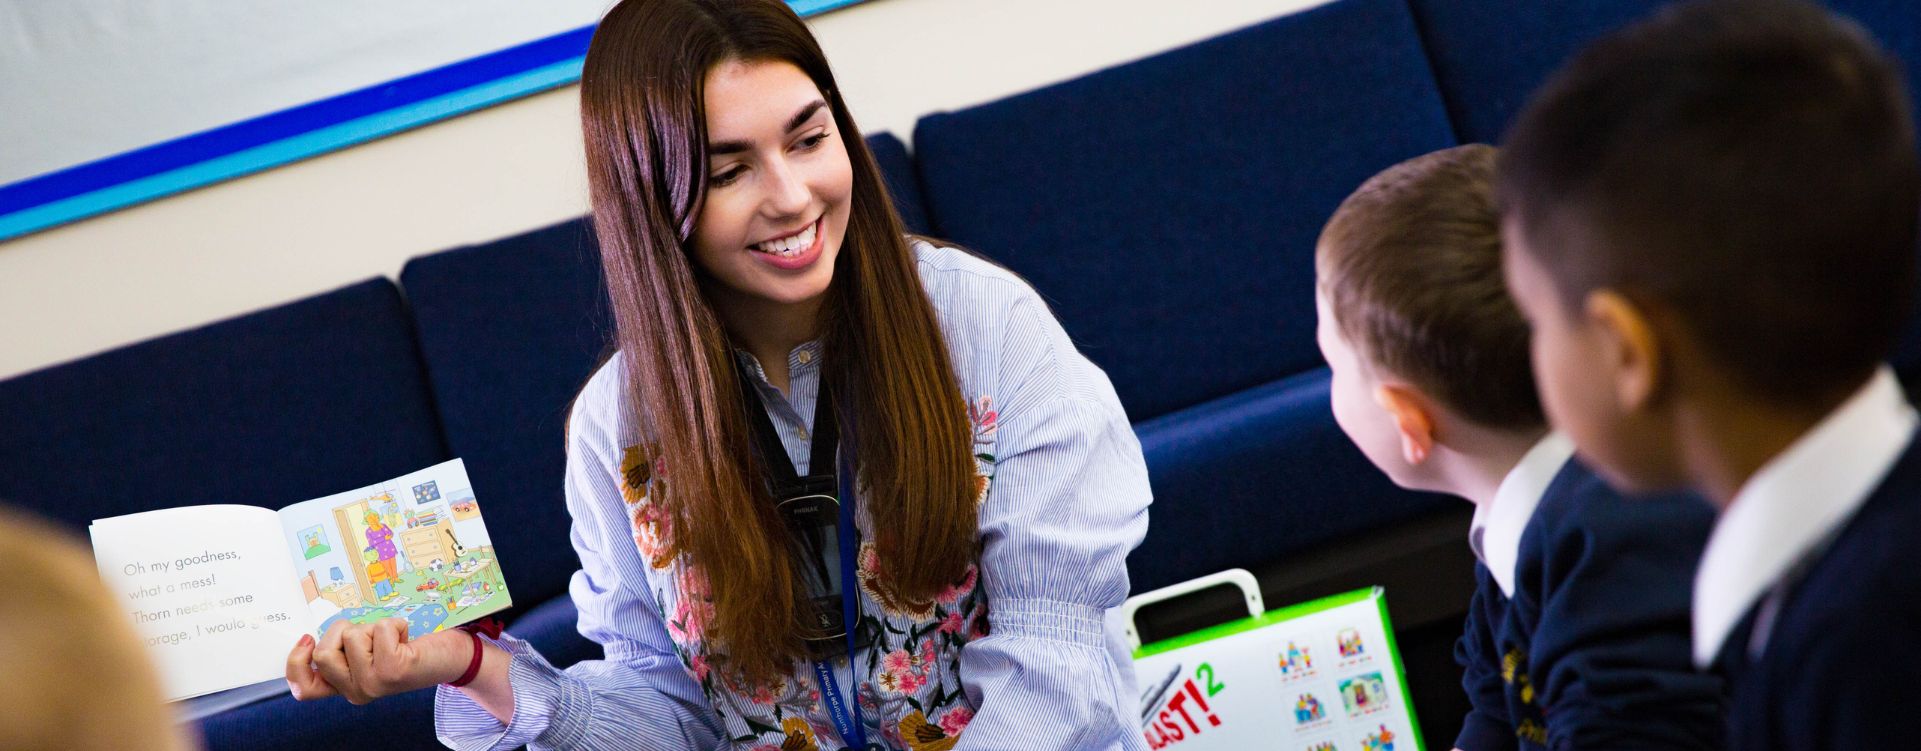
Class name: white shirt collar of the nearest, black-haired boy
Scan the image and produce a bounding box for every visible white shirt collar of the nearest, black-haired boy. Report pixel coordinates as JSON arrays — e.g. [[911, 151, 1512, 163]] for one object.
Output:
[[1694, 367, 1917, 666]]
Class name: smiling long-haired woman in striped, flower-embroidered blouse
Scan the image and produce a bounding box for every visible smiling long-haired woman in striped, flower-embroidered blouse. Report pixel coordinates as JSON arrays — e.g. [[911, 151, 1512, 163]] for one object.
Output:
[[288, 0, 1149, 751]]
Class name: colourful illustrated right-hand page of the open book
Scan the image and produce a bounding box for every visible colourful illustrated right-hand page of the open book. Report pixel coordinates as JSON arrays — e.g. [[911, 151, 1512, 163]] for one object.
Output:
[[280, 459, 513, 638]]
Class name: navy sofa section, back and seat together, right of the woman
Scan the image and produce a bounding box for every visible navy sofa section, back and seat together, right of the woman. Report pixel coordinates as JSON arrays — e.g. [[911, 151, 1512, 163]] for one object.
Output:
[[914, 0, 1460, 588]]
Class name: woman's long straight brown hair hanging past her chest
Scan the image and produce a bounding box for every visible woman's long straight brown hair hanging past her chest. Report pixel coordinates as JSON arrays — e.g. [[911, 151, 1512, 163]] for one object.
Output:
[[580, 0, 980, 682]]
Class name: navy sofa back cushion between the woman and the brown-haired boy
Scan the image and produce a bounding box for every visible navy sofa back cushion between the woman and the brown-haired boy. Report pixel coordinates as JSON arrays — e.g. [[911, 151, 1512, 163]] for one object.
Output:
[[914, 0, 1454, 421]]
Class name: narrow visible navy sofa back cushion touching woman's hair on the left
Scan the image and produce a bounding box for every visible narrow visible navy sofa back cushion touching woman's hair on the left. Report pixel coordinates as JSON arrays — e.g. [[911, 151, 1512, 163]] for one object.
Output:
[[400, 219, 613, 607]]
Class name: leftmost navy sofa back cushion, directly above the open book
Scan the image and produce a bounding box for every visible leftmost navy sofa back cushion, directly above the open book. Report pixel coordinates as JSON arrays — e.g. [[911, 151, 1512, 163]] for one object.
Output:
[[0, 279, 448, 530]]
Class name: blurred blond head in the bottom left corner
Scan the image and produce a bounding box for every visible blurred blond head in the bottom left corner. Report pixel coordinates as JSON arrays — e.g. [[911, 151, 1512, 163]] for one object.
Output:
[[0, 509, 188, 751]]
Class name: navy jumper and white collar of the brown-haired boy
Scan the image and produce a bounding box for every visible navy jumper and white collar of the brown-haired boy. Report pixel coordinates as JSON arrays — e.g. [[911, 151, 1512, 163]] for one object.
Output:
[[1454, 434, 1725, 751]]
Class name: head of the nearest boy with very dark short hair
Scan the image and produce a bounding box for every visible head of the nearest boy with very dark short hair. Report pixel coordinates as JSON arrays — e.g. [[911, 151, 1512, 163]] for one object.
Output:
[[1496, 0, 1921, 490]]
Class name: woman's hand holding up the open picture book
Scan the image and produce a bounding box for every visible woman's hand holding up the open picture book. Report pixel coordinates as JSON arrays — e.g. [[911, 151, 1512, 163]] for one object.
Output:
[[286, 618, 473, 705]]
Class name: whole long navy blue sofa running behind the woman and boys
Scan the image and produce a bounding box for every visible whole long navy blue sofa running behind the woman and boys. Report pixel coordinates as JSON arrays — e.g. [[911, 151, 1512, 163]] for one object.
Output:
[[0, 0, 1921, 749]]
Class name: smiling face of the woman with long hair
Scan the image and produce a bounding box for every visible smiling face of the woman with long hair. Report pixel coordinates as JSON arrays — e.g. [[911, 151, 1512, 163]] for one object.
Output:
[[693, 60, 853, 314]]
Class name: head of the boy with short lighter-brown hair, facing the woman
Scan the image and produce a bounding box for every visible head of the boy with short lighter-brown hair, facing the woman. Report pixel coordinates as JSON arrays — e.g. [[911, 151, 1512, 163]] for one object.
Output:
[[1314, 144, 1544, 490]]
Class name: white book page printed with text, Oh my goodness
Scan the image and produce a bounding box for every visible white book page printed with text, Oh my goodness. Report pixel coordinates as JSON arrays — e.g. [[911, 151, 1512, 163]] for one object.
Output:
[[88, 505, 309, 701]]
